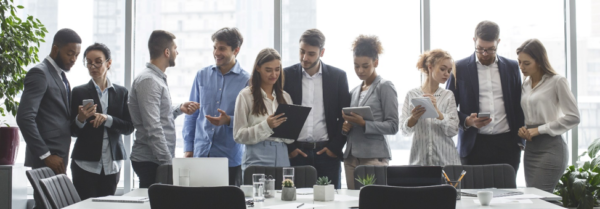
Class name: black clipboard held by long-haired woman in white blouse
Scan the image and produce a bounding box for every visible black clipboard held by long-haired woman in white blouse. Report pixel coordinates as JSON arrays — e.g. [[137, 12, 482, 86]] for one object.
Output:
[[271, 104, 312, 140]]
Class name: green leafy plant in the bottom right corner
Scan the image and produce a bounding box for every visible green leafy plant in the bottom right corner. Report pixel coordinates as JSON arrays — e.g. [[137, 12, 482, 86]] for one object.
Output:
[[554, 139, 600, 209]]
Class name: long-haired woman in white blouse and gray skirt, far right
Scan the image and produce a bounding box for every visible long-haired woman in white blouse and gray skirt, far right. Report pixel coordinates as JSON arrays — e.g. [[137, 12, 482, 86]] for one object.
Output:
[[517, 39, 579, 192]]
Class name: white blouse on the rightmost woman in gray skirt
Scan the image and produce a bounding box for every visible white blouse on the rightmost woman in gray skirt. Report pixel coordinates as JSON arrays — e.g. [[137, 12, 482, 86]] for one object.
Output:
[[521, 74, 579, 136]]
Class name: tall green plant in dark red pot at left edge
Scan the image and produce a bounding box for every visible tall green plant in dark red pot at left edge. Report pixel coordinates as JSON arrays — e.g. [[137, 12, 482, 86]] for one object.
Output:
[[0, 0, 48, 165]]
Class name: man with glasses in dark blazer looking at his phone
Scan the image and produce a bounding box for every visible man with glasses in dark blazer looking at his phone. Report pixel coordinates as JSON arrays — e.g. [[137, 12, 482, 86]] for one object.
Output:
[[446, 21, 525, 172]]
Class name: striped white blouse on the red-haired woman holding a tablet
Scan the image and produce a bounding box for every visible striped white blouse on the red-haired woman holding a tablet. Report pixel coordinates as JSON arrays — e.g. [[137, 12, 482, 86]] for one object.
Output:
[[400, 88, 461, 166]]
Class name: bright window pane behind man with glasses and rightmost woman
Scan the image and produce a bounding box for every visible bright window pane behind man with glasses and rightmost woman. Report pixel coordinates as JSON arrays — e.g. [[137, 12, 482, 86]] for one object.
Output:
[[431, 0, 566, 186]]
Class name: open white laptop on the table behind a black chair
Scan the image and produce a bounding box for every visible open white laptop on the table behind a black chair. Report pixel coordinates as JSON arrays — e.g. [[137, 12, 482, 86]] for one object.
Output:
[[173, 157, 229, 187]]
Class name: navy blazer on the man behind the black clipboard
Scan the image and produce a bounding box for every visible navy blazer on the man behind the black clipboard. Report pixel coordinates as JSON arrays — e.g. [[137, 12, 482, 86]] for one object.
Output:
[[283, 61, 350, 160]]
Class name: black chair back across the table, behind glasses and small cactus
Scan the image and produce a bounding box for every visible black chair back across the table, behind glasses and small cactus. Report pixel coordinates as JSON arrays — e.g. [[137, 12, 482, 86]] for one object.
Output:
[[244, 165, 317, 190]]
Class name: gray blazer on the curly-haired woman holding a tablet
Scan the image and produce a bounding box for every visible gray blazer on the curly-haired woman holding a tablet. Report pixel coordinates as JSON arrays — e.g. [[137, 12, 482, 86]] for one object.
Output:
[[344, 76, 399, 159]]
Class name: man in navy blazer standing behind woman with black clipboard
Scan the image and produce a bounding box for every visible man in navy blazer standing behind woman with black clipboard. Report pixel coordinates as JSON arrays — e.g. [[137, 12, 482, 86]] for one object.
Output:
[[283, 29, 350, 189]]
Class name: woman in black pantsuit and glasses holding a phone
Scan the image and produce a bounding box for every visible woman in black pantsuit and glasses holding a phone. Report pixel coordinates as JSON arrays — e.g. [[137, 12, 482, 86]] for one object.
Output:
[[71, 43, 134, 200]]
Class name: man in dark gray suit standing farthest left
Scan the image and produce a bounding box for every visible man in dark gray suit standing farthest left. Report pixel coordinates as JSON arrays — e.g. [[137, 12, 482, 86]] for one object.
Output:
[[17, 28, 81, 208]]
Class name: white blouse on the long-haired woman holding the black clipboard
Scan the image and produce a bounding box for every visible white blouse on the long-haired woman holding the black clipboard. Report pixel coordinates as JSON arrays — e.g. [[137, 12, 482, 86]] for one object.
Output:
[[233, 87, 294, 144]]
